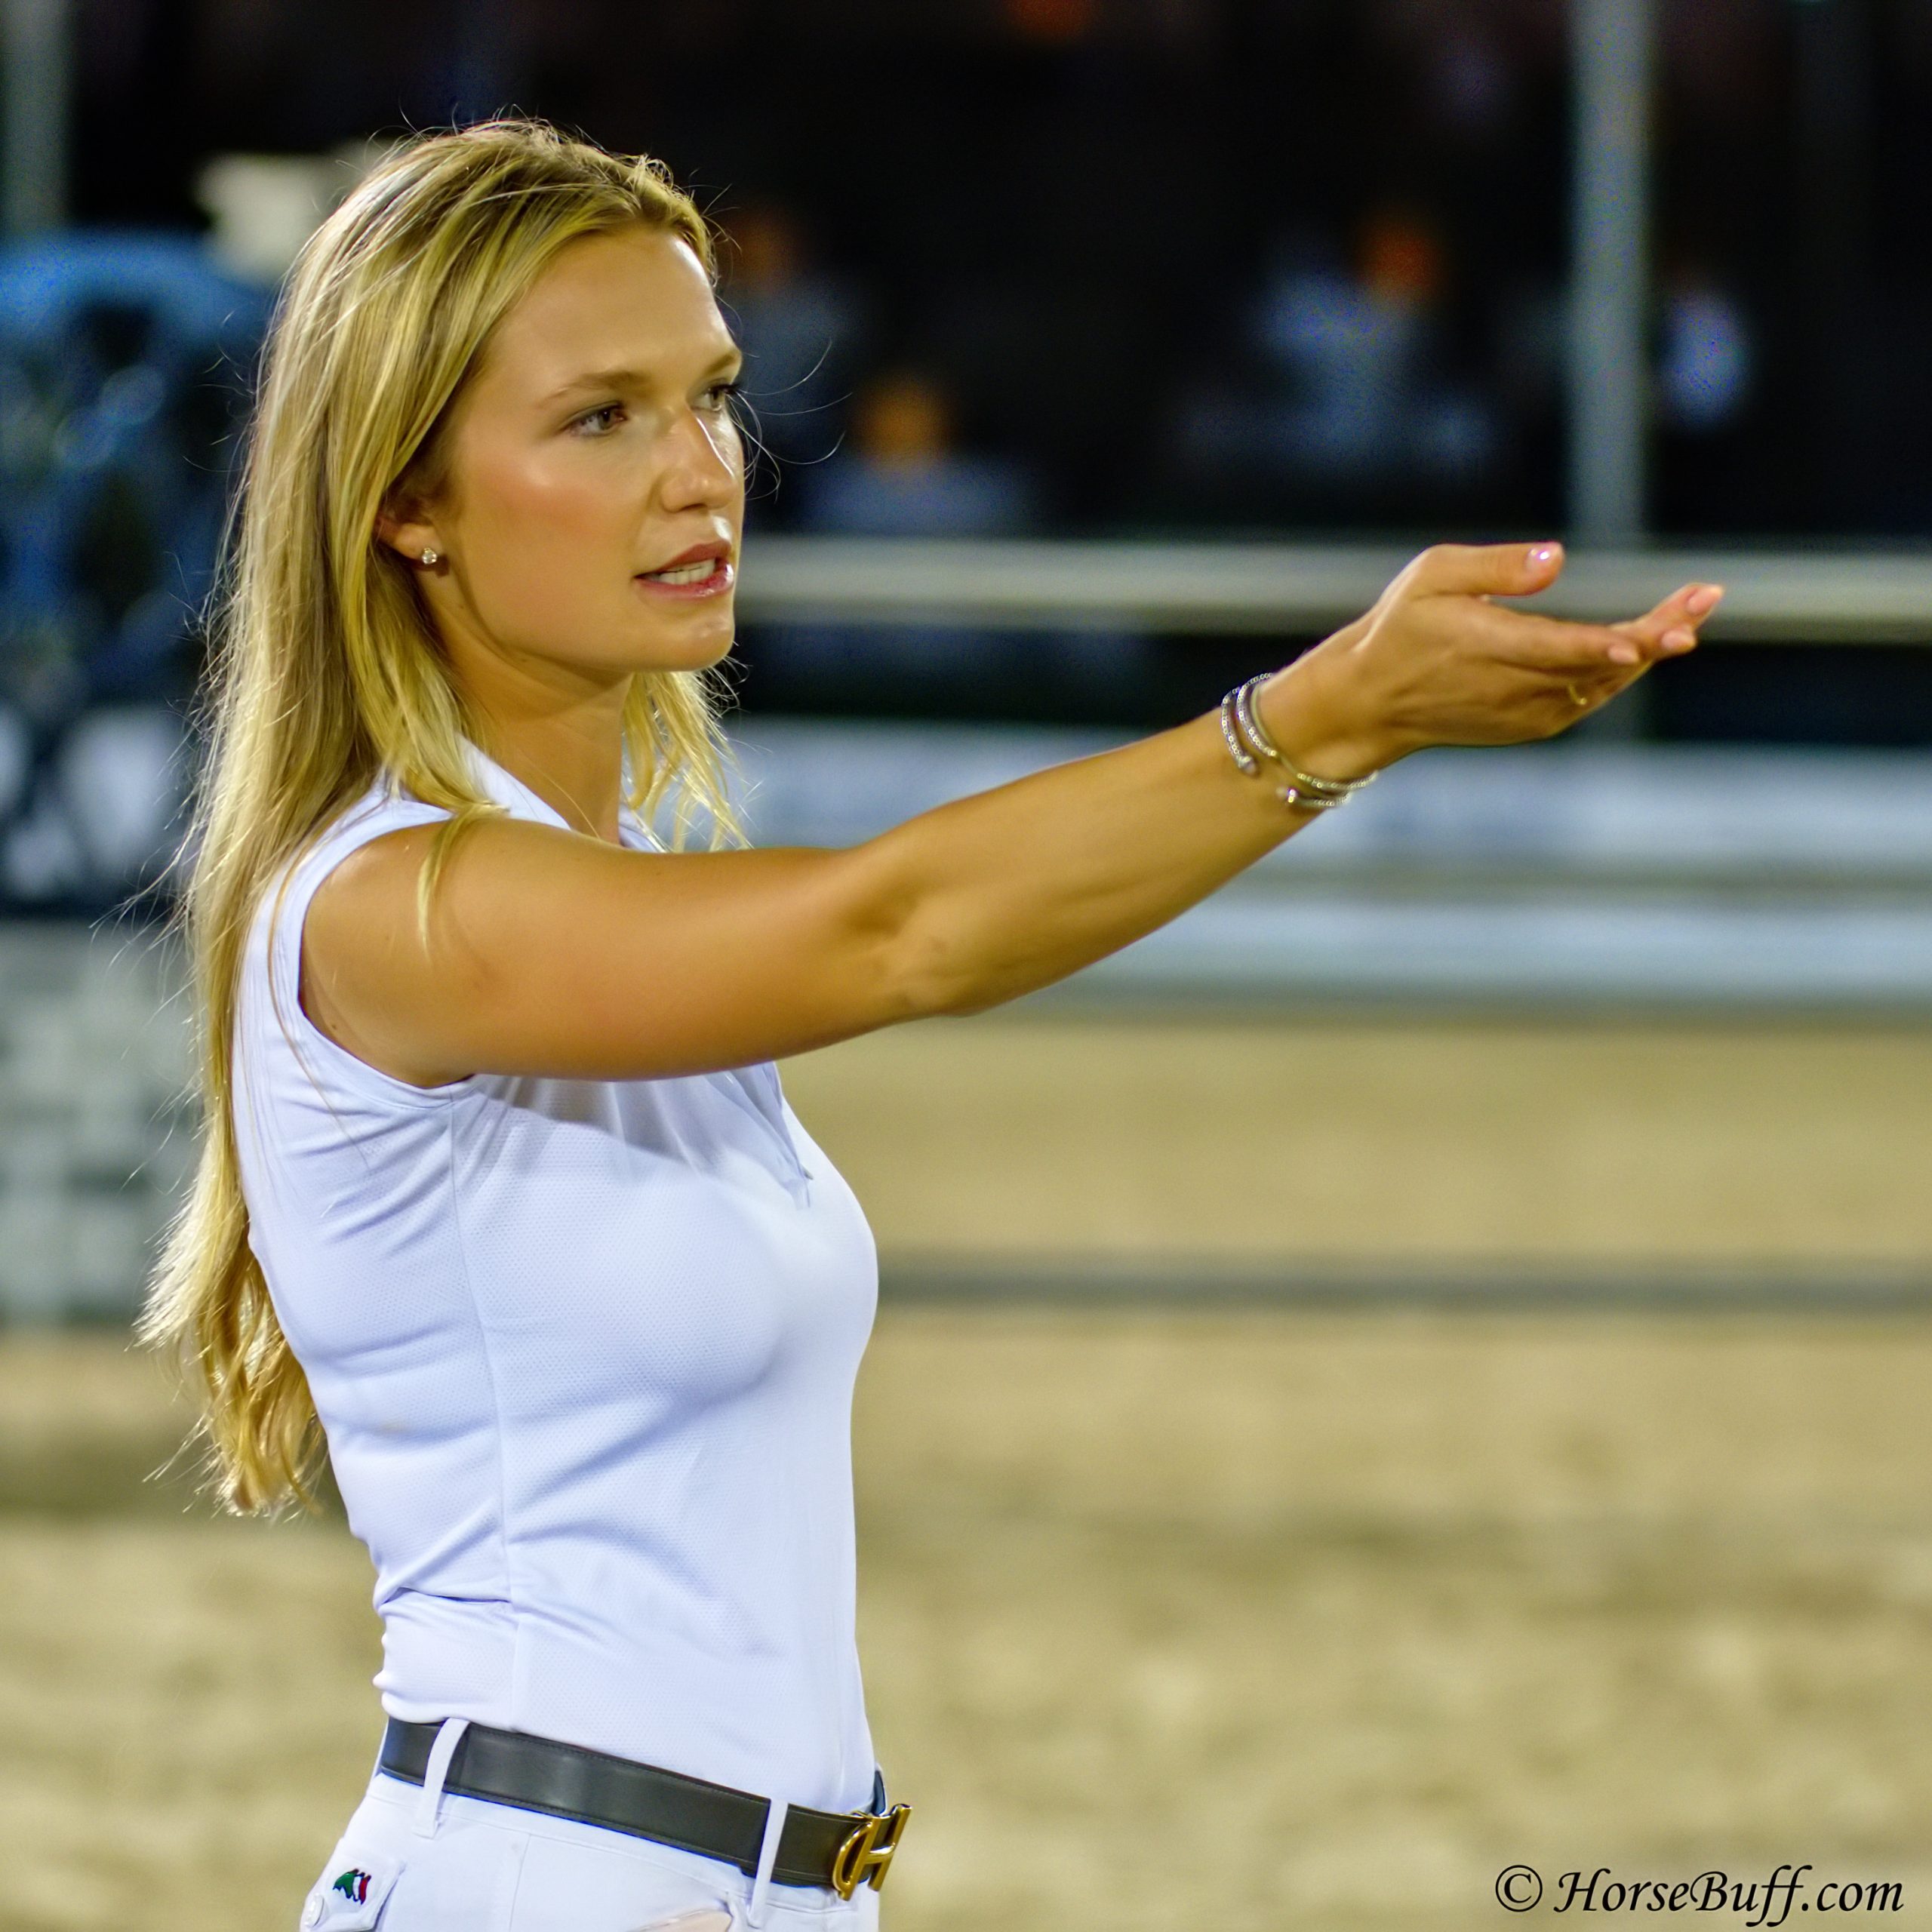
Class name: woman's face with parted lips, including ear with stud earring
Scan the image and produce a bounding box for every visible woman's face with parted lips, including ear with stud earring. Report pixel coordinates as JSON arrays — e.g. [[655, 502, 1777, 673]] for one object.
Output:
[[384, 228, 744, 688]]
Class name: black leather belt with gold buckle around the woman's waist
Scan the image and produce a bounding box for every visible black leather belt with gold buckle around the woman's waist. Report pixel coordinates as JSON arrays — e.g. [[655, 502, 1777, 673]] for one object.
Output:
[[377, 1718, 912, 1899]]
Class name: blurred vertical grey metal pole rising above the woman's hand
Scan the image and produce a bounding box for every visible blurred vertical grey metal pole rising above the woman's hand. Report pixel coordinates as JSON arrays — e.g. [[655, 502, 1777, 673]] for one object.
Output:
[[1569, 0, 1656, 545]]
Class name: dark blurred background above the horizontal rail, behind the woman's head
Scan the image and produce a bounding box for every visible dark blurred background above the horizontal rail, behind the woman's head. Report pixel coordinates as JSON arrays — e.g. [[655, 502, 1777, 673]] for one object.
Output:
[[56, 0, 1932, 535]]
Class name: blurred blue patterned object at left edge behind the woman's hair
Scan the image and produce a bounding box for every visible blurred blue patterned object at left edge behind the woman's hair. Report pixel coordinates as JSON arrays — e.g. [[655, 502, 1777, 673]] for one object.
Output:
[[0, 232, 272, 898]]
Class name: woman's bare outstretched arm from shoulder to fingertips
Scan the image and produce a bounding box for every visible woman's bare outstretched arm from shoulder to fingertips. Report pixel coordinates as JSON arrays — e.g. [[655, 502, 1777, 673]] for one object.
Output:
[[303, 545, 1715, 1086]]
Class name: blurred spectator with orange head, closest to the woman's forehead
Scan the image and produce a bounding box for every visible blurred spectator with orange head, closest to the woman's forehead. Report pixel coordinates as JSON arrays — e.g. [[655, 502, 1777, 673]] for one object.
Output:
[[721, 201, 866, 491]]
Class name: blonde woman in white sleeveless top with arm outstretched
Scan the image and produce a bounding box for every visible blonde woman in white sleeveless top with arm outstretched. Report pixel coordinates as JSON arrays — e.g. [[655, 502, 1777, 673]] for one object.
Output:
[[147, 124, 1718, 1932]]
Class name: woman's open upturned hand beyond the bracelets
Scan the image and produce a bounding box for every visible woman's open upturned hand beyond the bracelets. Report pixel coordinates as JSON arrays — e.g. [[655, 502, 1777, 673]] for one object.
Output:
[[1256, 543, 1724, 779]]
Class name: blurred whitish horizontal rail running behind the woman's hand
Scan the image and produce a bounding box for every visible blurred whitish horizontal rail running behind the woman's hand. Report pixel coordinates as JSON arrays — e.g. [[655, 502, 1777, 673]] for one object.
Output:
[[738, 535, 1932, 643]]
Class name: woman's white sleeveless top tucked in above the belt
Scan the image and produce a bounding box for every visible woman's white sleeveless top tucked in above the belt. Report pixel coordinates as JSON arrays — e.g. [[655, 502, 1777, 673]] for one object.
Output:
[[234, 748, 877, 1810]]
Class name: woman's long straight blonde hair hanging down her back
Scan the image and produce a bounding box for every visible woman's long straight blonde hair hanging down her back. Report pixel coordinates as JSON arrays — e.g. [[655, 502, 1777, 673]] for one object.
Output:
[[141, 120, 742, 1511]]
